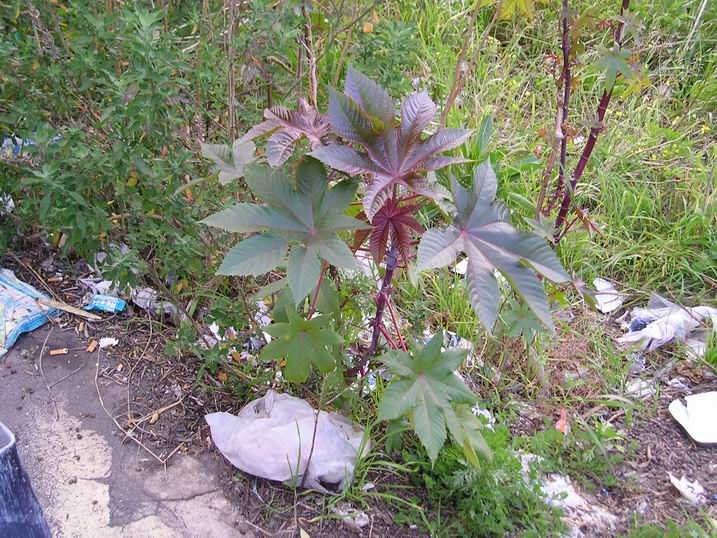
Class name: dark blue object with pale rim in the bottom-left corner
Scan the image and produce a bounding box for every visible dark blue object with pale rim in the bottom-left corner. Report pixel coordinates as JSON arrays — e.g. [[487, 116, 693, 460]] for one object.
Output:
[[0, 422, 52, 538]]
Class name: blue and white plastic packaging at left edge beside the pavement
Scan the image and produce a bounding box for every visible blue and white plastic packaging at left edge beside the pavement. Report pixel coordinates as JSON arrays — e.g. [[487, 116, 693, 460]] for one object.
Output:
[[0, 269, 58, 357]]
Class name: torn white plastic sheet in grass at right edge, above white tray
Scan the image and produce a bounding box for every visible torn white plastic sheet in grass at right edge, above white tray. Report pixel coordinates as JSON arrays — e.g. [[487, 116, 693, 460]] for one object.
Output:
[[618, 295, 717, 357]]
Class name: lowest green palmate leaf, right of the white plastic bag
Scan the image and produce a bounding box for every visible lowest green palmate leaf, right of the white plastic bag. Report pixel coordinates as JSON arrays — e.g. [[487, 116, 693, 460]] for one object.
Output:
[[378, 334, 487, 461]]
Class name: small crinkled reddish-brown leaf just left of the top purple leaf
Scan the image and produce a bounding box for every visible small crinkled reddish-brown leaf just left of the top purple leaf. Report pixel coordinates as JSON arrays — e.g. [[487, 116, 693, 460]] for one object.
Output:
[[239, 99, 329, 166]]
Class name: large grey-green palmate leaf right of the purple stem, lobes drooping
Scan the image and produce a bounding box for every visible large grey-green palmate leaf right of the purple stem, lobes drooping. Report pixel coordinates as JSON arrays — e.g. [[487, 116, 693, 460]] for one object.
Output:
[[418, 161, 568, 331]]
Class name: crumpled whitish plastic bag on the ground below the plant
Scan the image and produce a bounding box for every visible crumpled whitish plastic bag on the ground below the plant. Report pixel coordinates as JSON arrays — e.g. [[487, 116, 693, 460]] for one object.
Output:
[[204, 390, 370, 494]]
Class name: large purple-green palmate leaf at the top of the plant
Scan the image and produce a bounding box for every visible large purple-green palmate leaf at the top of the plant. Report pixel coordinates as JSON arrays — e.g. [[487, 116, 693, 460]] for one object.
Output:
[[311, 68, 472, 220]]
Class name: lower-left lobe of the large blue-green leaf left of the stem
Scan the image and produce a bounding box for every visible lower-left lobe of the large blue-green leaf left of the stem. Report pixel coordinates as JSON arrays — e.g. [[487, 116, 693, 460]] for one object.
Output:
[[217, 233, 290, 279]]
